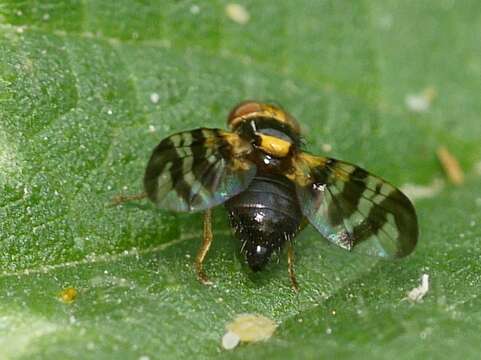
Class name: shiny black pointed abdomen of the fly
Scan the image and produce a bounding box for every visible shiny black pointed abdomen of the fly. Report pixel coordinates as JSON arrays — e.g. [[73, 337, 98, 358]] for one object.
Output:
[[225, 173, 303, 271]]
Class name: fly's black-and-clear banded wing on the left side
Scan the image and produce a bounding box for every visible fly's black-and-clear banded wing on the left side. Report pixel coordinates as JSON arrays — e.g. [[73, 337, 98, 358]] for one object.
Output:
[[144, 129, 256, 211]]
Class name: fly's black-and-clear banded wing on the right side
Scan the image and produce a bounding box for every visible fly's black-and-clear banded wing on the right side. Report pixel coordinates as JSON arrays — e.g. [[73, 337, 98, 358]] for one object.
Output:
[[289, 153, 418, 258]]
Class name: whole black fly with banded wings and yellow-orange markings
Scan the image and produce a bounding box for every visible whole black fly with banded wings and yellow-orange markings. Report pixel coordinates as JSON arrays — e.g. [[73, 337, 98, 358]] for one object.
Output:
[[138, 101, 418, 289]]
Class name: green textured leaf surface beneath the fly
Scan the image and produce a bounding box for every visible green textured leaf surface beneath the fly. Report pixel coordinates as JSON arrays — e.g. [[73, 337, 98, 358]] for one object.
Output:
[[0, 0, 481, 359]]
